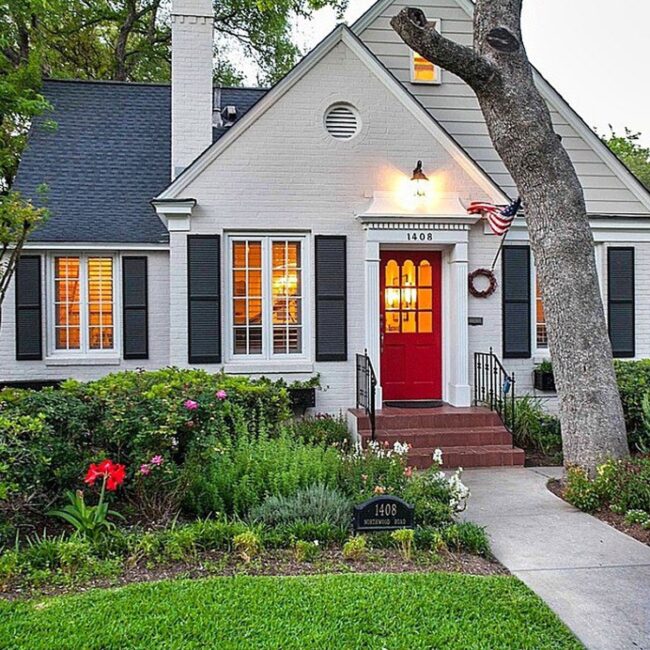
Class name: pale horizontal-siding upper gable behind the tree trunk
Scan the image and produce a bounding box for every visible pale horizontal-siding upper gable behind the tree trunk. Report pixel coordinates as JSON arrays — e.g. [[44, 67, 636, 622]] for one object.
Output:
[[353, 0, 650, 215]]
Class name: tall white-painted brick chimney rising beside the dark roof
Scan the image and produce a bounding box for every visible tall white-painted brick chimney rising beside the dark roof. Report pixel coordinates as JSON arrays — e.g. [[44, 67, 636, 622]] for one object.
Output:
[[172, 0, 214, 178]]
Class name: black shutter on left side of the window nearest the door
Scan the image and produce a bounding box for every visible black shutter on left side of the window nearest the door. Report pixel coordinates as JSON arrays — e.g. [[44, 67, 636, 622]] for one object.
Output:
[[187, 235, 221, 363]]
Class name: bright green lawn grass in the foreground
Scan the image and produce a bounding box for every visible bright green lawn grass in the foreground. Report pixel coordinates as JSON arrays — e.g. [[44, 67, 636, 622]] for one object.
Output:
[[0, 573, 582, 650]]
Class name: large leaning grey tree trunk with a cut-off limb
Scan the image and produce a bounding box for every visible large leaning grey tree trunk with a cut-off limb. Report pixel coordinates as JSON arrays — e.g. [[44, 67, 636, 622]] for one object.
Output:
[[391, 0, 629, 473]]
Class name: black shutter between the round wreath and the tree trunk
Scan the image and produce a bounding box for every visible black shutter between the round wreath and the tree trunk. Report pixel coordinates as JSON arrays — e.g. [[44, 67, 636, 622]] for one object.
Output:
[[502, 246, 532, 359]]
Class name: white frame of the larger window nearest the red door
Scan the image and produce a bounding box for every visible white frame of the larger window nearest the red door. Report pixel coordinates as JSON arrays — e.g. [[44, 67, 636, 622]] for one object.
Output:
[[224, 232, 312, 366]]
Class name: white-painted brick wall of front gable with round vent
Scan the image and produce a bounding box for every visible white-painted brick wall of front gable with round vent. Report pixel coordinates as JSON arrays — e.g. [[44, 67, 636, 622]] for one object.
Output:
[[171, 44, 494, 411]]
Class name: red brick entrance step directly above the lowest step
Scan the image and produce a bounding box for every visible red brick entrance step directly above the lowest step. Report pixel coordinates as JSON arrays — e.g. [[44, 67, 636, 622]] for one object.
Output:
[[360, 424, 512, 449]]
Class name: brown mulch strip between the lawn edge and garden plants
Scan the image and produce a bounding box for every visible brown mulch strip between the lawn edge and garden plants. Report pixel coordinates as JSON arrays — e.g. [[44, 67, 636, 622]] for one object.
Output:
[[0, 550, 508, 600]]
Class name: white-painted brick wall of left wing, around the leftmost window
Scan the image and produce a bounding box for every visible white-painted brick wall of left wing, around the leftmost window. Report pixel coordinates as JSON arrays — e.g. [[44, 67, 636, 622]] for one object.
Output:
[[0, 250, 170, 382]]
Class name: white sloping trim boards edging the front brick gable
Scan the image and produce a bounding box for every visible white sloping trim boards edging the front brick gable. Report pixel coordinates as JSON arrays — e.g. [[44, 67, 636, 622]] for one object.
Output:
[[157, 25, 507, 202]]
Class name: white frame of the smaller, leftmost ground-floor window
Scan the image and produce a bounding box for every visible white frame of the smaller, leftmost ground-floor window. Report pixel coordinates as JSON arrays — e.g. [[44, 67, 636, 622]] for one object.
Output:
[[45, 250, 122, 359]]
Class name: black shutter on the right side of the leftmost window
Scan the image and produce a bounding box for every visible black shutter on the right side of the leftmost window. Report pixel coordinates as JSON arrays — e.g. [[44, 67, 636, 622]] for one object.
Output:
[[122, 257, 149, 359]]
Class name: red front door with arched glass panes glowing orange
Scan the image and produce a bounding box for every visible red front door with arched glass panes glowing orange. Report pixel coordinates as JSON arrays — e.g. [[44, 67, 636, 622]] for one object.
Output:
[[381, 251, 442, 400]]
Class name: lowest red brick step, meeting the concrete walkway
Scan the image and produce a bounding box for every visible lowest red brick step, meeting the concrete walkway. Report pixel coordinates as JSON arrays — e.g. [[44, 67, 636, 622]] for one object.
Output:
[[408, 445, 524, 469]]
